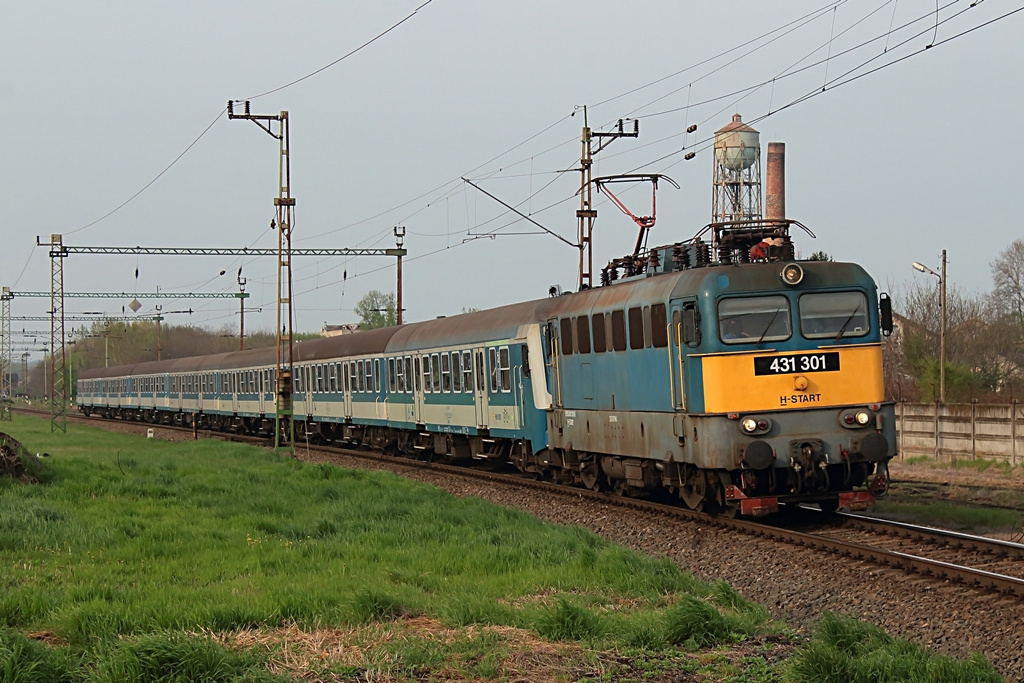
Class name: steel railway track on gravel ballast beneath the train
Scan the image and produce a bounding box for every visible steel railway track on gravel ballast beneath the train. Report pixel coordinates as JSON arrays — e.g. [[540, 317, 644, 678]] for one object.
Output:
[[18, 409, 1024, 599]]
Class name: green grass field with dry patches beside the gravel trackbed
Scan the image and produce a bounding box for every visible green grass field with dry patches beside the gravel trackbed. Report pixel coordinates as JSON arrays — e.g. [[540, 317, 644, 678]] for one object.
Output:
[[0, 415, 999, 683]]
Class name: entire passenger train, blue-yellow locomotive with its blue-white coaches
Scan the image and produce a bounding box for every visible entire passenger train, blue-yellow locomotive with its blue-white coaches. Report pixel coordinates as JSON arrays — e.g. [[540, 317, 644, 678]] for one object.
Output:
[[78, 221, 896, 515]]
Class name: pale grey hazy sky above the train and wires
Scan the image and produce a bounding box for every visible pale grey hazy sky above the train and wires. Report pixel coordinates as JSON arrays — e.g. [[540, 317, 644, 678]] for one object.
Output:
[[0, 0, 1024, 360]]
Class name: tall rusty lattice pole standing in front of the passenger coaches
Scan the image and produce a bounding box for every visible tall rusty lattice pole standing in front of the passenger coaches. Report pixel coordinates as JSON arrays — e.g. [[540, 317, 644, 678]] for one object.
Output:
[[227, 100, 295, 457]]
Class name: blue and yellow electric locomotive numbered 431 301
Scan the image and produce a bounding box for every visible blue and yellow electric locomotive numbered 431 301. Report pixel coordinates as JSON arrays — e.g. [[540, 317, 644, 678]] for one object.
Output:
[[532, 228, 896, 515]]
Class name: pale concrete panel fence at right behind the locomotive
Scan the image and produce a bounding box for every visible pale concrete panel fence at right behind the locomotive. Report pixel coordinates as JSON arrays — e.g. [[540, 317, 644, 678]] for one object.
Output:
[[896, 401, 1024, 466]]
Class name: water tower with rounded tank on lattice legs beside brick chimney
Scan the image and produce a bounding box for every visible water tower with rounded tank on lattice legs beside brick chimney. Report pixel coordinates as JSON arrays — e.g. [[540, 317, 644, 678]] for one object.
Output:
[[711, 114, 761, 223]]
